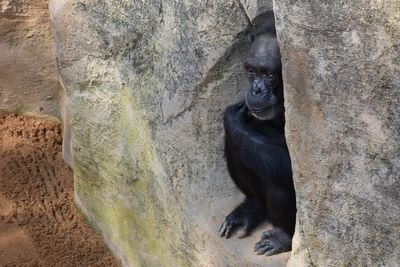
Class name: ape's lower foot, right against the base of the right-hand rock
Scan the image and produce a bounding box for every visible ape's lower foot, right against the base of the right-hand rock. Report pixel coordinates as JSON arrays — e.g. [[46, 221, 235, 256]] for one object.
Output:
[[254, 228, 292, 256]]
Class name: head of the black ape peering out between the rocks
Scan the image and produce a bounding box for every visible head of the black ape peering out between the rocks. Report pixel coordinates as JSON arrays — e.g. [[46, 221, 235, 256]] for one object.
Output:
[[244, 35, 284, 120]]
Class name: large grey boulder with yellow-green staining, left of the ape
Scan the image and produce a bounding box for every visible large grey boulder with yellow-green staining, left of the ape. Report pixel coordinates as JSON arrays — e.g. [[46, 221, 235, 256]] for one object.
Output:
[[50, 0, 289, 266]]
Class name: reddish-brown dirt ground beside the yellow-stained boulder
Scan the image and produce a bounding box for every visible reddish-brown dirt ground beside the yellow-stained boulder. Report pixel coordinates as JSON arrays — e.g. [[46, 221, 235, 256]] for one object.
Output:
[[0, 113, 119, 267]]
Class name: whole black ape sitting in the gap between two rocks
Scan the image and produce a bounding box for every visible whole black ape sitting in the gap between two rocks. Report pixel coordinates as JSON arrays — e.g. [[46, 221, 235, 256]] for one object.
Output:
[[219, 19, 296, 255]]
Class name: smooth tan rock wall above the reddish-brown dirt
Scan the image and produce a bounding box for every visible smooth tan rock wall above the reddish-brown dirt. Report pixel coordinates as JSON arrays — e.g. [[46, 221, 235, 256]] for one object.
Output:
[[0, 0, 61, 117]]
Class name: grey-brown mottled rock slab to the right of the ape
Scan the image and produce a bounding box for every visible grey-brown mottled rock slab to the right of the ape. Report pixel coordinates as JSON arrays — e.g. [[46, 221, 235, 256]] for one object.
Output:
[[275, 0, 400, 266]]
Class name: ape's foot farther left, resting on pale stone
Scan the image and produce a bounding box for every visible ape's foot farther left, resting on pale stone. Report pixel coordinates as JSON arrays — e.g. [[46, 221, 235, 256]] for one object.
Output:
[[219, 200, 266, 238]]
